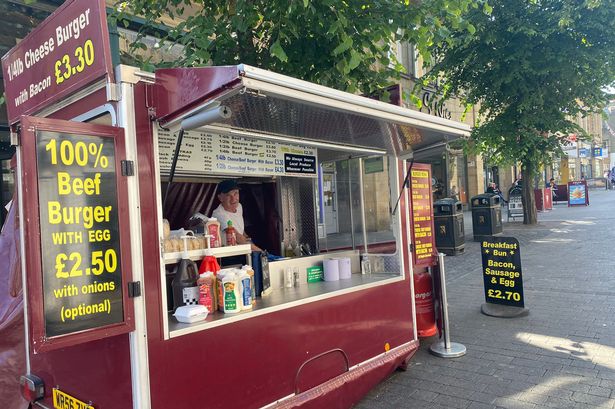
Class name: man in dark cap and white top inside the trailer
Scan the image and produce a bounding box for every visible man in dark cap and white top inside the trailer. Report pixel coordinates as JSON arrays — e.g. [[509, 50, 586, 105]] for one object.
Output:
[[211, 179, 262, 251]]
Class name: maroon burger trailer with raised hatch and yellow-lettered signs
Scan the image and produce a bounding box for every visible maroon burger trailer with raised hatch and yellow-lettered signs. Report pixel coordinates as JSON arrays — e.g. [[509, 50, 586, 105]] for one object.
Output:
[[2, 0, 468, 409]]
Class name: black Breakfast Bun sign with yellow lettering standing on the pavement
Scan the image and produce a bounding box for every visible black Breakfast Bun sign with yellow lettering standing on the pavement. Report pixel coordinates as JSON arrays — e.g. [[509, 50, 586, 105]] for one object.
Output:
[[481, 236, 524, 308]]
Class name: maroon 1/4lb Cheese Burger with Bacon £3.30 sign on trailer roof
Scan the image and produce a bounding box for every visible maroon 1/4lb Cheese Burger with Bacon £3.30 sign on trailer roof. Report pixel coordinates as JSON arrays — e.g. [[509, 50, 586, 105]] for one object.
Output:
[[2, 0, 112, 124]]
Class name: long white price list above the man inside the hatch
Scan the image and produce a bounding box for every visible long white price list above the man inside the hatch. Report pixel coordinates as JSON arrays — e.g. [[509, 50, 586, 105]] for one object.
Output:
[[158, 128, 318, 177]]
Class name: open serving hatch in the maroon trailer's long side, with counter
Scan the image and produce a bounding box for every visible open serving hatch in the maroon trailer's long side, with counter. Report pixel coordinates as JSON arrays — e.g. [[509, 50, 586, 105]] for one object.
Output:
[[155, 128, 403, 338]]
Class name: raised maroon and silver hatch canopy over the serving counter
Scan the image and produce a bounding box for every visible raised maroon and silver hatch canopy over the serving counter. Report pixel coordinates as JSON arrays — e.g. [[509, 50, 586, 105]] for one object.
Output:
[[155, 65, 470, 155]]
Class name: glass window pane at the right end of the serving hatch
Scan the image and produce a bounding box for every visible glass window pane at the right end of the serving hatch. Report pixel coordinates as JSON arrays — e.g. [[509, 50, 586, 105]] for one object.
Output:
[[317, 155, 396, 254]]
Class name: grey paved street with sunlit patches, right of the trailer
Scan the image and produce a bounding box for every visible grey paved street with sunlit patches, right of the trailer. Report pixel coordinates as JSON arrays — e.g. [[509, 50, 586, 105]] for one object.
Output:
[[356, 186, 615, 409]]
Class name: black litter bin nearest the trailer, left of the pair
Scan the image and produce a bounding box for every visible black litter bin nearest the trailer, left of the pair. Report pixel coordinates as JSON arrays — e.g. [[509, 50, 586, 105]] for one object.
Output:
[[433, 198, 465, 256]]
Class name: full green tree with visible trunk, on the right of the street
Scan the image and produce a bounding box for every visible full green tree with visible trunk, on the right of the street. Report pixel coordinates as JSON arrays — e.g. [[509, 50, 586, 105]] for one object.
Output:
[[423, 0, 615, 224]]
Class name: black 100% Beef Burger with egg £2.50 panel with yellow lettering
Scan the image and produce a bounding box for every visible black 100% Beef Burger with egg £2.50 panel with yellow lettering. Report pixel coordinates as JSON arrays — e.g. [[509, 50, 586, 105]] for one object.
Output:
[[36, 131, 124, 337]]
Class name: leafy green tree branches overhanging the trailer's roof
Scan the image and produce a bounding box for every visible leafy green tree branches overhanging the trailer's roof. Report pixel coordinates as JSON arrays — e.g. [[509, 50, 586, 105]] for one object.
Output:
[[115, 0, 482, 94]]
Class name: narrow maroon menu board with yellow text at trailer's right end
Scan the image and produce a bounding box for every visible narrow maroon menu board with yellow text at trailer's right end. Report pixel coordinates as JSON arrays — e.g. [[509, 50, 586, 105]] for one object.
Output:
[[410, 163, 436, 266]]
